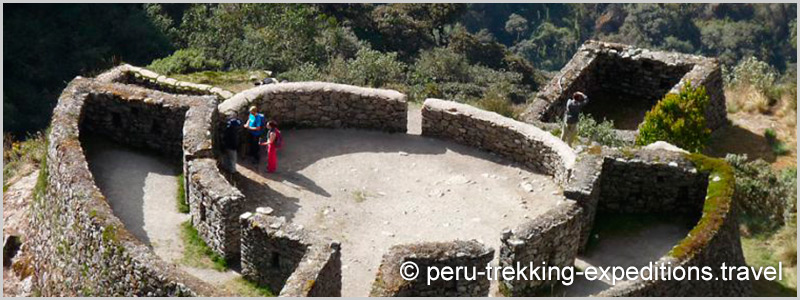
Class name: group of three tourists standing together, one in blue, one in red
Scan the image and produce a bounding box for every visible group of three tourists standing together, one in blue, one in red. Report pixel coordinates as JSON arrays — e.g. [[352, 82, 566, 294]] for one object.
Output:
[[223, 106, 283, 173]]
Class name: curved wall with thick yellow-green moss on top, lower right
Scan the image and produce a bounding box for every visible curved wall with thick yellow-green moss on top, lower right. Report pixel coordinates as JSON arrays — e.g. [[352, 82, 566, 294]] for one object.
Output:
[[597, 154, 752, 297]]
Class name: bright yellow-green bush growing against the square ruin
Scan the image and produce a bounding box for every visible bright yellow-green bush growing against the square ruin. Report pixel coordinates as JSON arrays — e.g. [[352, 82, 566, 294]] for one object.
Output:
[[636, 82, 711, 152]]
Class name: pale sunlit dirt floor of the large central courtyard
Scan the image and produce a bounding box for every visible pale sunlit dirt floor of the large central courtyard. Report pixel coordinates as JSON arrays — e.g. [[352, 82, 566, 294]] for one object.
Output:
[[235, 125, 563, 296]]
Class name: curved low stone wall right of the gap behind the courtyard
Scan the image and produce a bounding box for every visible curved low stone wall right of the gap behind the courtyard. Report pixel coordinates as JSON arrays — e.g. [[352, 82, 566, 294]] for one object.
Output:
[[422, 99, 575, 183]]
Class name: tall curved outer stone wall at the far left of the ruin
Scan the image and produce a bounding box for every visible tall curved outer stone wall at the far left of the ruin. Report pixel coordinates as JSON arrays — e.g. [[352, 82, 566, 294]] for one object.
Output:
[[26, 78, 215, 296]]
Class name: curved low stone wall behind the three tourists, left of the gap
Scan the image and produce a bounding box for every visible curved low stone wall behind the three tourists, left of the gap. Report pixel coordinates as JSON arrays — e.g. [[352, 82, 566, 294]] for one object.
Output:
[[219, 82, 408, 132]]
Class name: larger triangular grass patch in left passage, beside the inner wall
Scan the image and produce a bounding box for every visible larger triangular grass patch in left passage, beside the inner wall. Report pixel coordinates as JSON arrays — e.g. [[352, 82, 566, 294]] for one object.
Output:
[[181, 221, 228, 272]]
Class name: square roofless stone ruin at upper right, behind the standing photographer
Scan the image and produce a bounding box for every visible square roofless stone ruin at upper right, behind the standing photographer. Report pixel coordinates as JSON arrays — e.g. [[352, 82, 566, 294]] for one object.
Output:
[[522, 40, 727, 141]]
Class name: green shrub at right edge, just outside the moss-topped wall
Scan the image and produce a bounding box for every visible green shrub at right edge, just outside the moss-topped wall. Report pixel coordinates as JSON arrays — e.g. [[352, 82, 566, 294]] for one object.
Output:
[[725, 154, 797, 232]]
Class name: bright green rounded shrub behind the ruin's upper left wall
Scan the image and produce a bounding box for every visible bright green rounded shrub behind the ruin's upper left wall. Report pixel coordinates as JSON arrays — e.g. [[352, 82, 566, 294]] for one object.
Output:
[[147, 48, 222, 75]]
